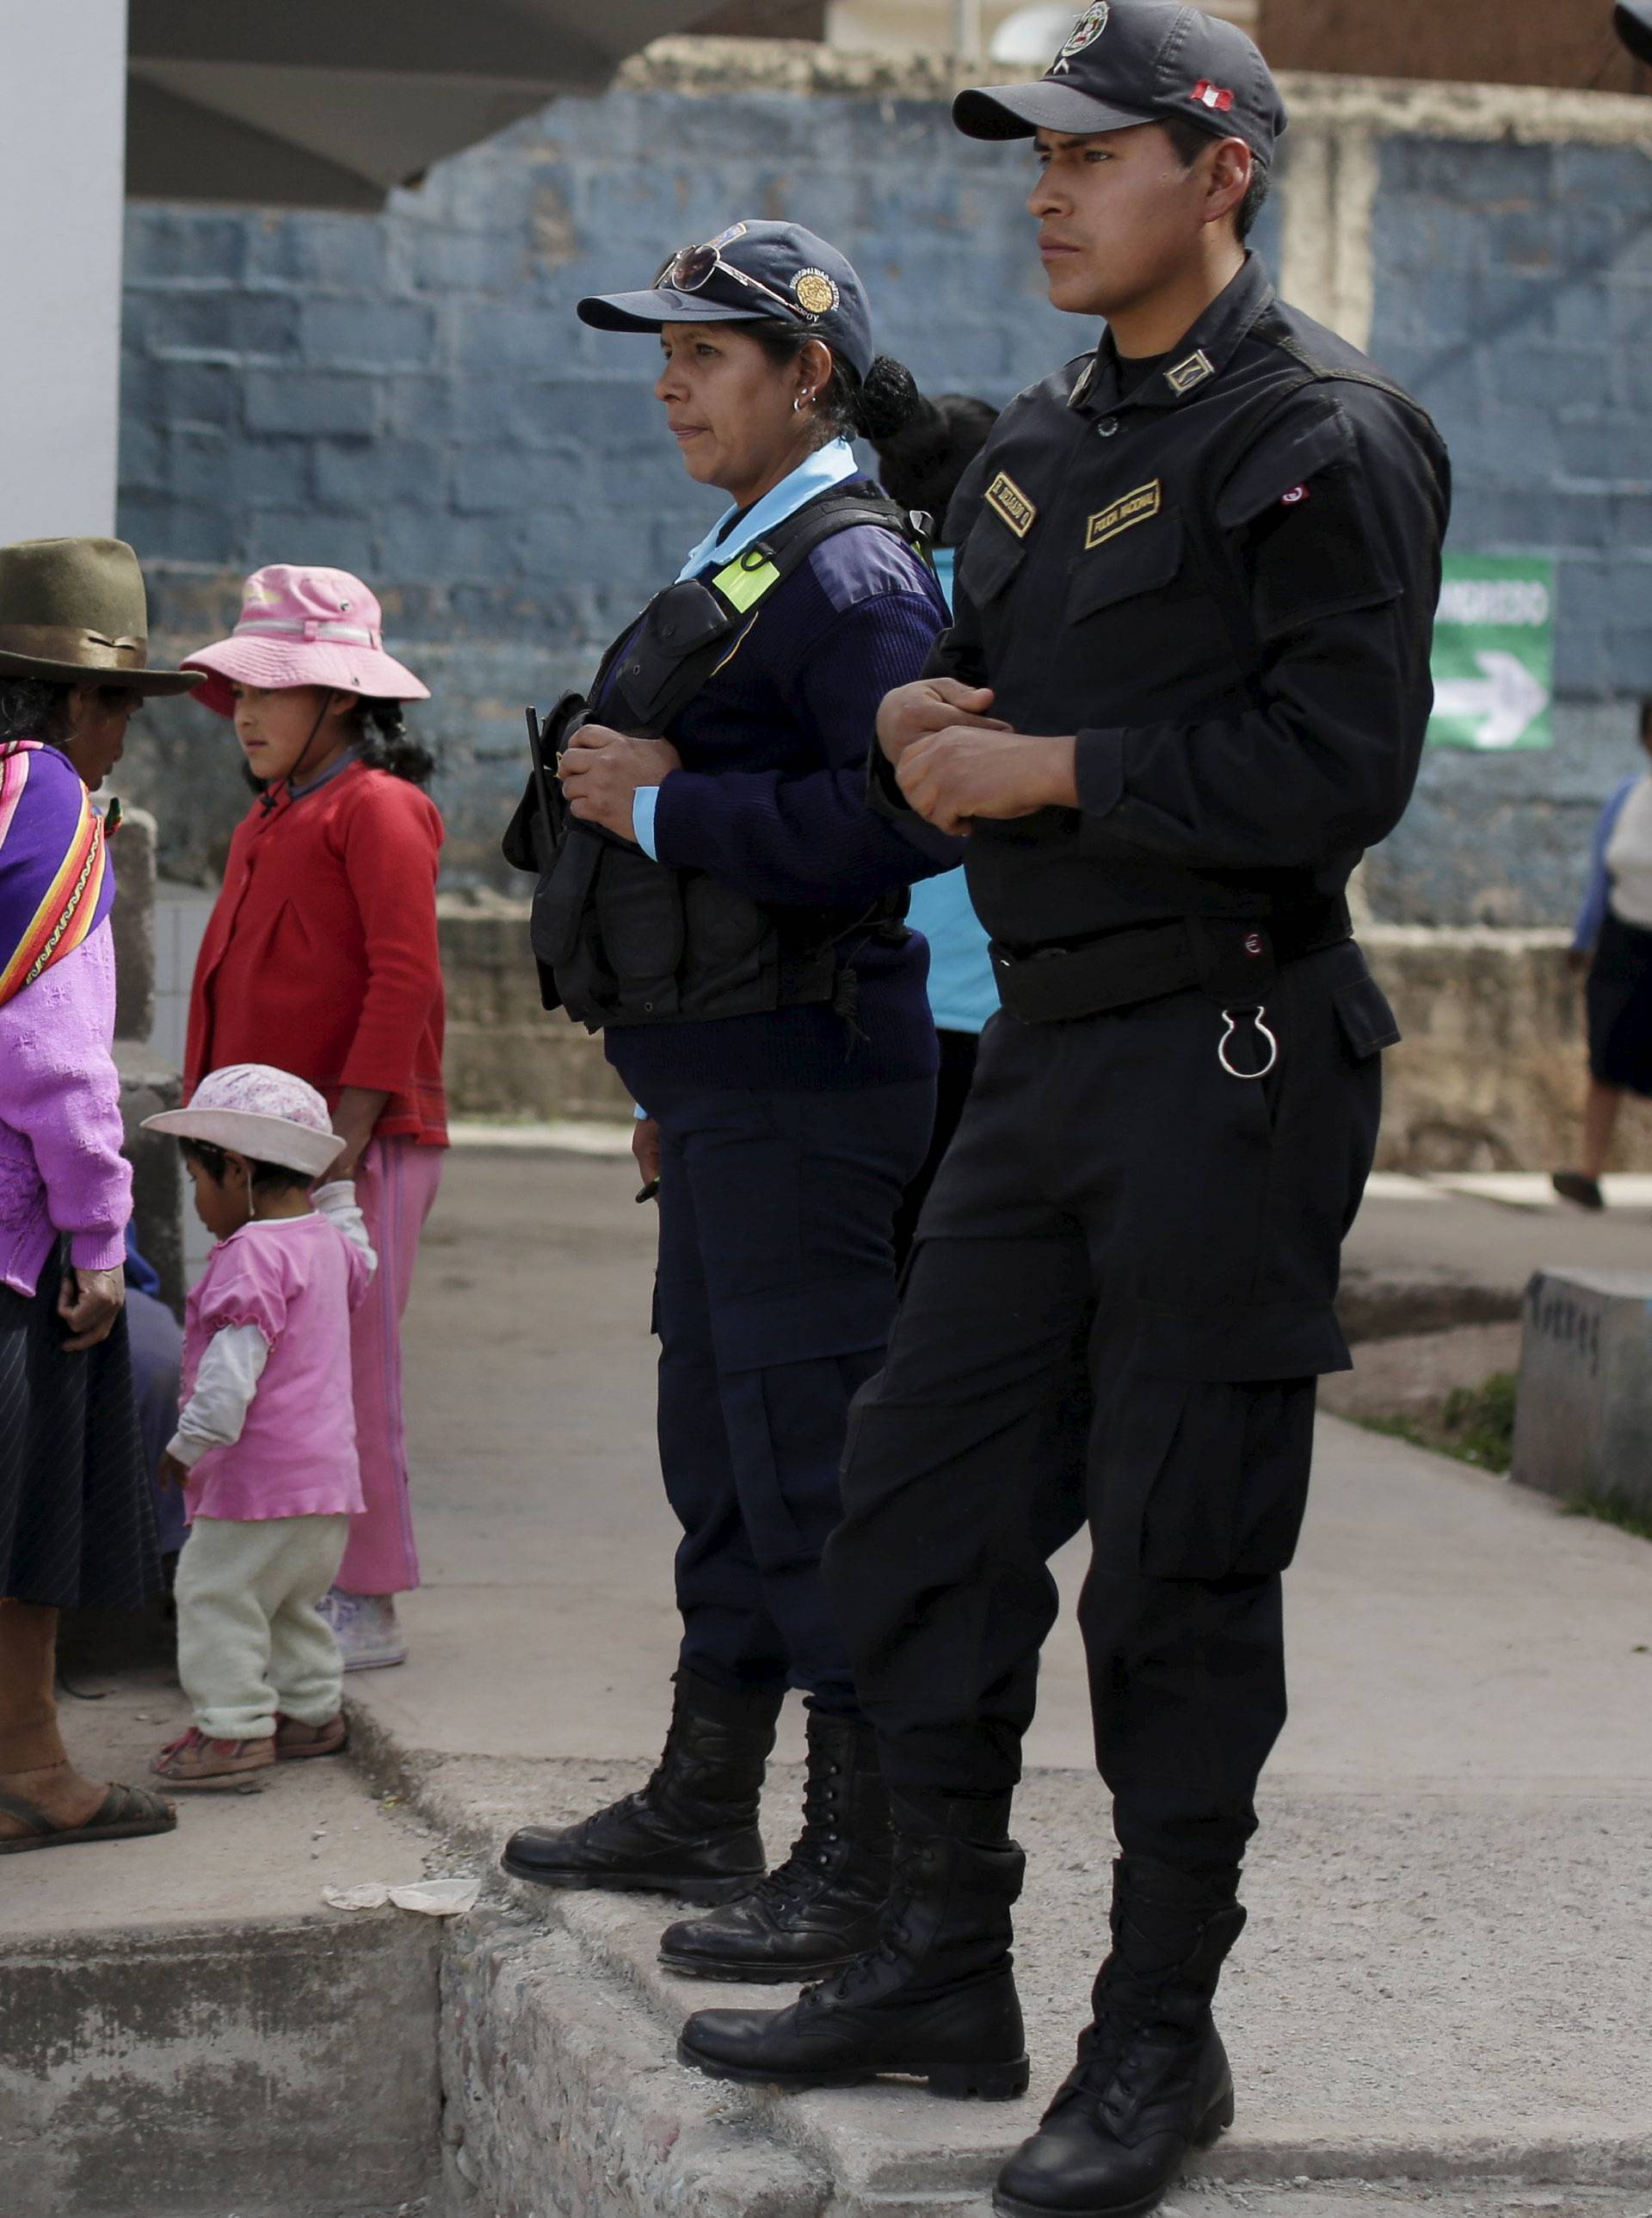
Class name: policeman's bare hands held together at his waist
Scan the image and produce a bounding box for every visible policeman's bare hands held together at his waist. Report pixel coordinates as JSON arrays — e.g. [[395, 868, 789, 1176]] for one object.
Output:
[[878, 679, 1078, 834]]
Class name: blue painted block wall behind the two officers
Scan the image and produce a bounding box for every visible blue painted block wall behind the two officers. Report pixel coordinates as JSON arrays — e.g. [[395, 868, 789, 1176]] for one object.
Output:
[[120, 66, 1652, 922]]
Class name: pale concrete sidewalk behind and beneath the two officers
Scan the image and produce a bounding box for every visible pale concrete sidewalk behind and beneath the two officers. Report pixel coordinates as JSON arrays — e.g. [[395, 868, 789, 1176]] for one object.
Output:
[[339, 1149, 1652, 2218]]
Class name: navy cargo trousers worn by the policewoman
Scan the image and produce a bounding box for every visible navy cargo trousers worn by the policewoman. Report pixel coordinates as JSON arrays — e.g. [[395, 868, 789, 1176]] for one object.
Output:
[[648, 1078, 936, 1715]]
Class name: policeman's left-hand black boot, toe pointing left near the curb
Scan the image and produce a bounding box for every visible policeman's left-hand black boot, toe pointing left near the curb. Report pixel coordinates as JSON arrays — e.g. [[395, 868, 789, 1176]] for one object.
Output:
[[676, 1795, 1026, 2098]]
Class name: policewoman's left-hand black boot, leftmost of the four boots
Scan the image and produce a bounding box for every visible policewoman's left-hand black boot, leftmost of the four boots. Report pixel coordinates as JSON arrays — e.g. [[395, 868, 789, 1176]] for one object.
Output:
[[501, 1670, 785, 1903]]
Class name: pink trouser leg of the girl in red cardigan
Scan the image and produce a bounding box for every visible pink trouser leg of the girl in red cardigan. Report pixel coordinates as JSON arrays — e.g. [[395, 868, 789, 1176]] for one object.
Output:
[[337, 1138, 443, 1597]]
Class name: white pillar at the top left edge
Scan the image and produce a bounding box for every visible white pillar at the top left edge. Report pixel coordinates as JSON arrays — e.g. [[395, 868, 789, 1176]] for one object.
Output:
[[0, 0, 126, 544]]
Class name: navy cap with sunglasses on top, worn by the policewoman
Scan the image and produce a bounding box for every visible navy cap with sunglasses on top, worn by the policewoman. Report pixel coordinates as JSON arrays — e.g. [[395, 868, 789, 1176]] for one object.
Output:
[[576, 218, 873, 377]]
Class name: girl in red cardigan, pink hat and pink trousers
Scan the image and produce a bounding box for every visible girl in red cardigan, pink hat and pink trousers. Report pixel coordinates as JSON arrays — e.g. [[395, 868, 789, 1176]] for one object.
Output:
[[184, 564, 448, 1670]]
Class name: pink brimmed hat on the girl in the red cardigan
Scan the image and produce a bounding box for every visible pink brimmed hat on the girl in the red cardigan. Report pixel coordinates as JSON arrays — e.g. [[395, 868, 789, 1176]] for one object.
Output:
[[182, 561, 430, 717]]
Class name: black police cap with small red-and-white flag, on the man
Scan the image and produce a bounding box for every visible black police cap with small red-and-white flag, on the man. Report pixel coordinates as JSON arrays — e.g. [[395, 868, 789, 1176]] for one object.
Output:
[[952, 0, 1286, 164]]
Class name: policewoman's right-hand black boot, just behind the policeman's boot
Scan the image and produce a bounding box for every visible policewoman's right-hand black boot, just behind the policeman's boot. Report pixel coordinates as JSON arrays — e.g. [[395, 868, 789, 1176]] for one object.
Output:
[[658, 1710, 891, 1985]]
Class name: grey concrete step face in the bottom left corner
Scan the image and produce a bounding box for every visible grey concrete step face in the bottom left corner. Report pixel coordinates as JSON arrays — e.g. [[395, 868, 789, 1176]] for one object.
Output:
[[0, 1907, 441, 2218]]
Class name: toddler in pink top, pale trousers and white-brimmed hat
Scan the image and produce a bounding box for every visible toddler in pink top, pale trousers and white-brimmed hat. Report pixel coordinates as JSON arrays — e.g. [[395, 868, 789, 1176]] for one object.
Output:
[[145, 1063, 375, 1788]]
